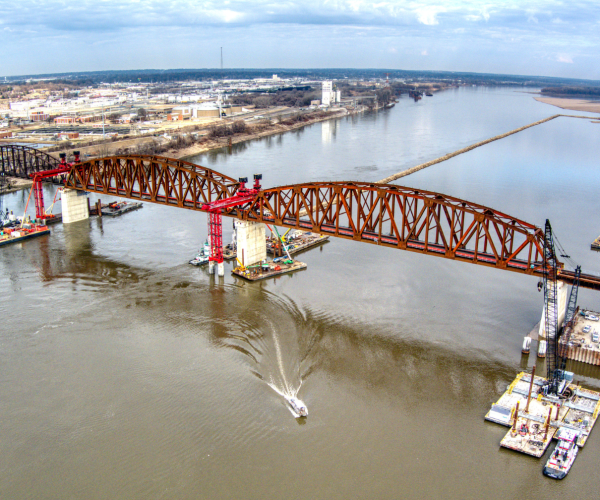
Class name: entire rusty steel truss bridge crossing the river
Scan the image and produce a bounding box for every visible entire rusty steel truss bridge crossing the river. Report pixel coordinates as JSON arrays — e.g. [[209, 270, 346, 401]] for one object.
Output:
[[0, 146, 600, 290]]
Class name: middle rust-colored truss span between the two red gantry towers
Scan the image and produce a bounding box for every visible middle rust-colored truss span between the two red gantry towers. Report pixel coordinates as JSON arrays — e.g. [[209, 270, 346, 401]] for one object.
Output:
[[66, 155, 239, 210]]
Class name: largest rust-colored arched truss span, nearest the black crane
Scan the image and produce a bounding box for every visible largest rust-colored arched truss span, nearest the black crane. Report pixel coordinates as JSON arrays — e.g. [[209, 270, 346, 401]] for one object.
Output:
[[231, 182, 544, 275]]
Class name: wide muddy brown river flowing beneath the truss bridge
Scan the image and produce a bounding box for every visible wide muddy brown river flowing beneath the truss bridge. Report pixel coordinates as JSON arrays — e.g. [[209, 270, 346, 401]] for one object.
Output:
[[0, 87, 600, 499]]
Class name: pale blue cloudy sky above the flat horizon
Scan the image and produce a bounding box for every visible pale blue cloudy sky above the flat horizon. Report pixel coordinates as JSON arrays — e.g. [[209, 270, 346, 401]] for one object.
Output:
[[0, 0, 600, 80]]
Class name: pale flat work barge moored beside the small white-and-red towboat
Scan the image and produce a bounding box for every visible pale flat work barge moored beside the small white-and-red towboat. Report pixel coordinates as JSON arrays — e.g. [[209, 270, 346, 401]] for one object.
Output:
[[485, 372, 600, 458]]
